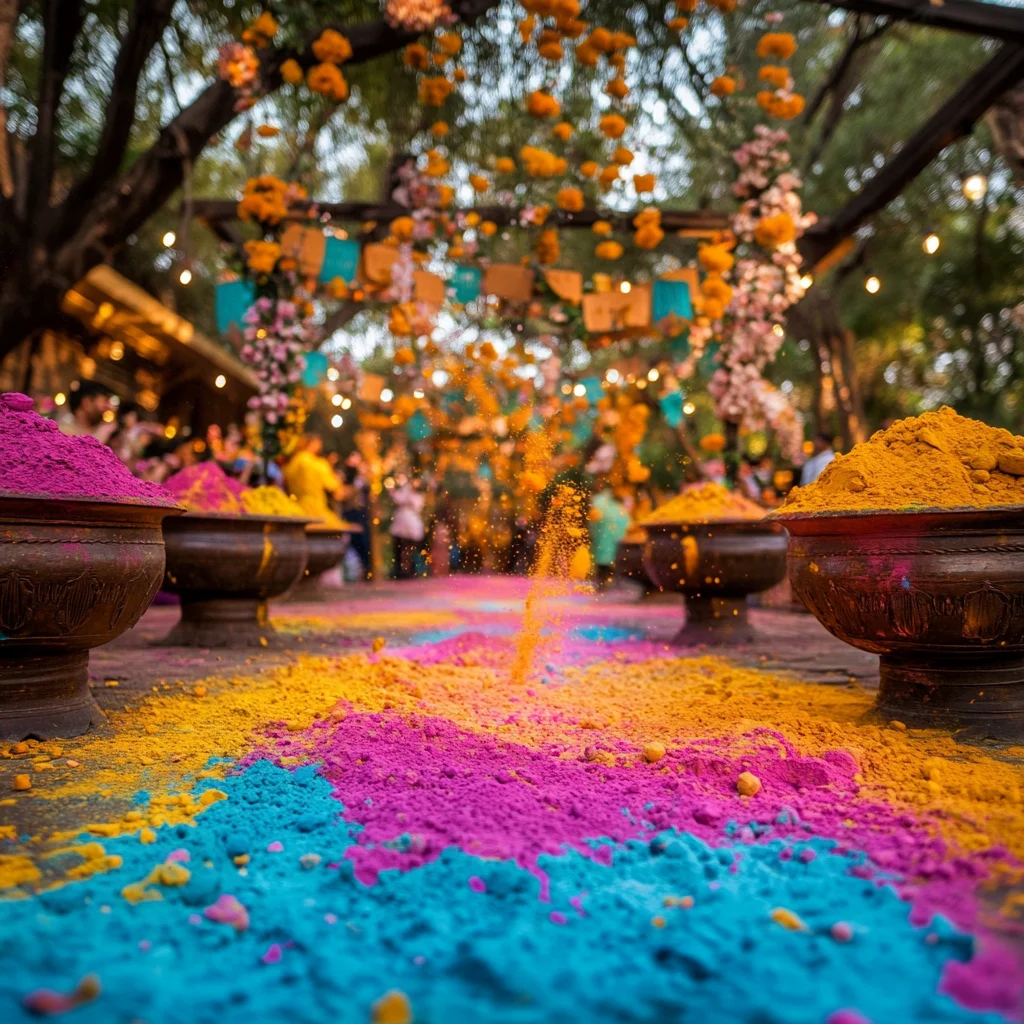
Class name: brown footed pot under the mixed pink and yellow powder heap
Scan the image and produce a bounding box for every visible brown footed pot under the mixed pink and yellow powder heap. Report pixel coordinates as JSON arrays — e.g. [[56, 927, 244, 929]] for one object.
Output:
[[162, 512, 309, 647]]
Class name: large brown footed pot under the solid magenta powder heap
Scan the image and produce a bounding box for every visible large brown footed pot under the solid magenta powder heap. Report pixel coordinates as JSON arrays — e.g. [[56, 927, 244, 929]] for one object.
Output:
[[0, 495, 181, 740]]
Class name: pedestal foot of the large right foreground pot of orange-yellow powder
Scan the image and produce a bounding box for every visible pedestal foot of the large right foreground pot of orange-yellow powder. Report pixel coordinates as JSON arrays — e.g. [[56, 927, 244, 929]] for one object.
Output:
[[876, 654, 1024, 741]]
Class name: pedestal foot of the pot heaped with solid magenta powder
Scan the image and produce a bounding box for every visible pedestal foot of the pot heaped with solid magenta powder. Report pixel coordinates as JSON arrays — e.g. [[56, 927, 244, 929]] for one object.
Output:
[[0, 651, 103, 741]]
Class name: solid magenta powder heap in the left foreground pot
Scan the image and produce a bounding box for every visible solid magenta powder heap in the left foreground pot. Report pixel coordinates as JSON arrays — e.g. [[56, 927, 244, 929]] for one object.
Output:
[[0, 391, 175, 508]]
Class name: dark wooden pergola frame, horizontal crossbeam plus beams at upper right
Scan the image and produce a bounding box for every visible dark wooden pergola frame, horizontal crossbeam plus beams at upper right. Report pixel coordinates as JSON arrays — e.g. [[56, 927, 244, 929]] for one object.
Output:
[[191, 0, 1024, 274]]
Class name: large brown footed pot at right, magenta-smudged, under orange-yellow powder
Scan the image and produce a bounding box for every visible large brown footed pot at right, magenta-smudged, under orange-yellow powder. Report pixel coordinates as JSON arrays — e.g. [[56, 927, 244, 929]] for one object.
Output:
[[781, 508, 1024, 739]]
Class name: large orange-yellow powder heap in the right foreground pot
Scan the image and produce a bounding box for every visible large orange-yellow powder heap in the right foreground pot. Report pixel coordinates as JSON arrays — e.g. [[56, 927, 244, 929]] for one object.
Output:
[[776, 407, 1024, 516]]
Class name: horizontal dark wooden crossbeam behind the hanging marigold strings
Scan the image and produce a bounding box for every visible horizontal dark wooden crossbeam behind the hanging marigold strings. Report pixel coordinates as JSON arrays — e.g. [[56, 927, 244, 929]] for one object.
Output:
[[193, 199, 729, 237]]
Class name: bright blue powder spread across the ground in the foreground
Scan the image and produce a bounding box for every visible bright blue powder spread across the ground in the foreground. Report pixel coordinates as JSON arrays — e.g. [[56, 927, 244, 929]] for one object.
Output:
[[0, 762, 999, 1024]]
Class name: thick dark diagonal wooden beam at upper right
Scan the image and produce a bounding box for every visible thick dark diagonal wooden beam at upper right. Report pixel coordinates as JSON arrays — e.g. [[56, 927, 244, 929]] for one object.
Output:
[[800, 43, 1024, 267]]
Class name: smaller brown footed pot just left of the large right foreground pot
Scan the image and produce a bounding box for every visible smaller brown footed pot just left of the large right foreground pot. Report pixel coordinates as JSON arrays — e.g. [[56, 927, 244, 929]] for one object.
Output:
[[643, 519, 787, 645]]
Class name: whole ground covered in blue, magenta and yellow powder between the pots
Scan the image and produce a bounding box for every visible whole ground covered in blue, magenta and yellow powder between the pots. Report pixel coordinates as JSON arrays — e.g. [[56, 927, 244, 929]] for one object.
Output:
[[0, 579, 1024, 1024]]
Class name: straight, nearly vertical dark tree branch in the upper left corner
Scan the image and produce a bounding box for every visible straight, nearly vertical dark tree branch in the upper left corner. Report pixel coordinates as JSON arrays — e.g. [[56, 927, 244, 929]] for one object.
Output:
[[19, 0, 84, 226]]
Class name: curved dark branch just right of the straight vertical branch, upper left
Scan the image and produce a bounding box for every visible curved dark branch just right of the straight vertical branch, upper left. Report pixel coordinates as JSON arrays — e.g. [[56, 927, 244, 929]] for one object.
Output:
[[63, 0, 177, 228]]
